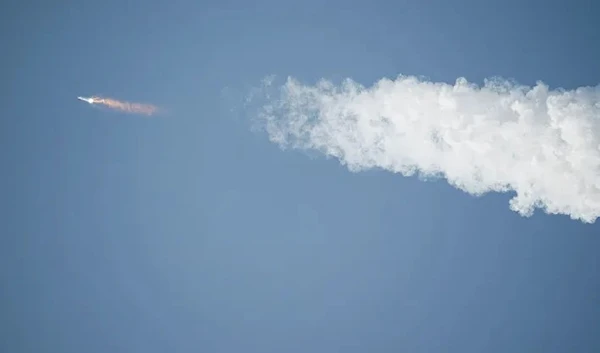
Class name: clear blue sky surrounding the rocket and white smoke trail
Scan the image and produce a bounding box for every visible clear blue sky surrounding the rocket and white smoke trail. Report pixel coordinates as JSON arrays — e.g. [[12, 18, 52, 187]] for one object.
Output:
[[0, 0, 600, 353]]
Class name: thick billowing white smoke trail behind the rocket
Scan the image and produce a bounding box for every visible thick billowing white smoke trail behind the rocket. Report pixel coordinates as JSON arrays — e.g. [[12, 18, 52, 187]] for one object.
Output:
[[255, 76, 600, 223]]
